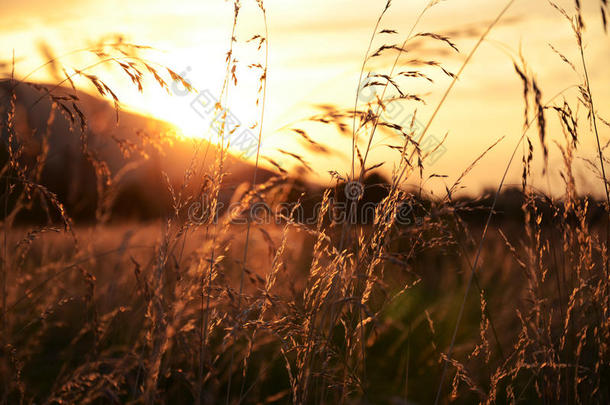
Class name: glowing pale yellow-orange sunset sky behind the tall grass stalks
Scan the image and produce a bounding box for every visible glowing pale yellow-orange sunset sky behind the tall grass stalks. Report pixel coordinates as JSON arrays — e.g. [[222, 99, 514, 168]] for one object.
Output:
[[0, 0, 610, 194]]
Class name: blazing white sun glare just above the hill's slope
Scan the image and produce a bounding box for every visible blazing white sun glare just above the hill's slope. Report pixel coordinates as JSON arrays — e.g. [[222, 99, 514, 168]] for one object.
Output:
[[119, 49, 262, 158]]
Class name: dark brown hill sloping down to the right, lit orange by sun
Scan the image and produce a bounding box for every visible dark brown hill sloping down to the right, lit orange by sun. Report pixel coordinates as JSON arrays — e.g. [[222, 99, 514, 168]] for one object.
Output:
[[0, 81, 272, 220]]
